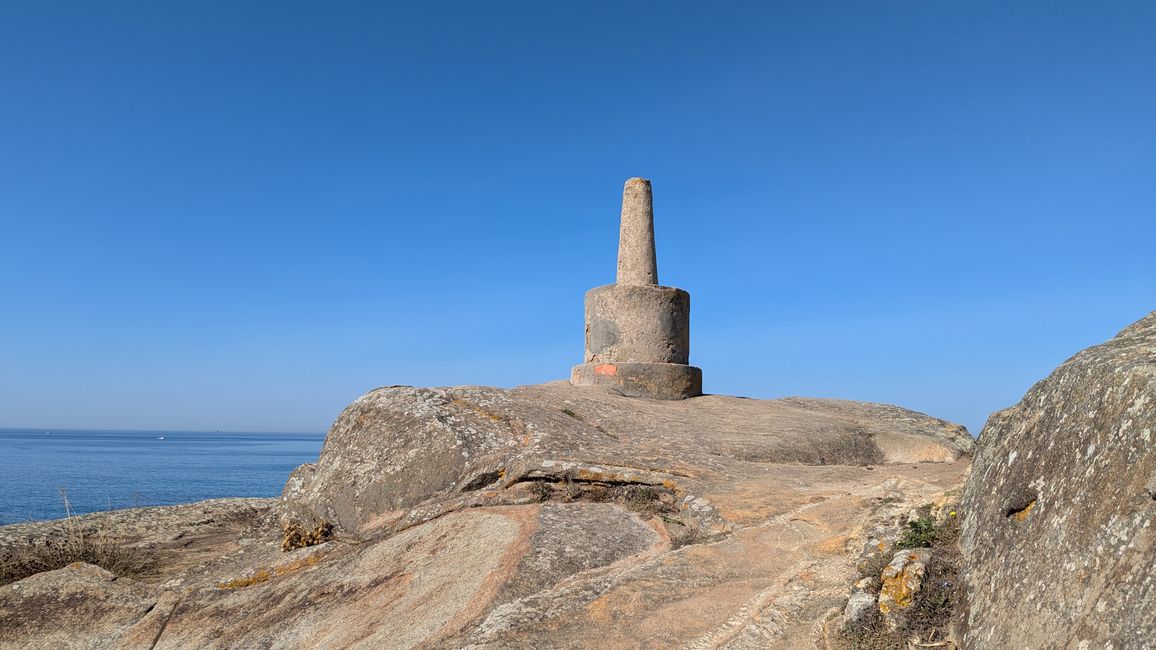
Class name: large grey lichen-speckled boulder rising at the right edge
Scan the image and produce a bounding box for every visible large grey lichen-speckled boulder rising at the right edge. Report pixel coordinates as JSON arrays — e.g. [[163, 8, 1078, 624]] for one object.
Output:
[[962, 312, 1156, 649]]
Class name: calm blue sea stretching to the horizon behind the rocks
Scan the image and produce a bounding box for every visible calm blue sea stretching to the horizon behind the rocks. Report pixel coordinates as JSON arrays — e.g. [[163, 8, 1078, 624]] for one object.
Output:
[[0, 429, 325, 525]]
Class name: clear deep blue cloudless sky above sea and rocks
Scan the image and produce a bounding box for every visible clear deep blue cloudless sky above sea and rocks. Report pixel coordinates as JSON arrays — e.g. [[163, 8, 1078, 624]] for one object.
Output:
[[0, 0, 1156, 433]]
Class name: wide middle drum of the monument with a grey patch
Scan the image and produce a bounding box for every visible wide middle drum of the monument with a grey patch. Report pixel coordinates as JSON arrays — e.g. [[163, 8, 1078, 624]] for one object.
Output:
[[585, 285, 690, 364]]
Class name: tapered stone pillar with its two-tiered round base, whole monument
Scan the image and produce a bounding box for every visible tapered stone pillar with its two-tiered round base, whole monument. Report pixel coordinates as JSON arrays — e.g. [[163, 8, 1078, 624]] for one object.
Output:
[[570, 178, 703, 399]]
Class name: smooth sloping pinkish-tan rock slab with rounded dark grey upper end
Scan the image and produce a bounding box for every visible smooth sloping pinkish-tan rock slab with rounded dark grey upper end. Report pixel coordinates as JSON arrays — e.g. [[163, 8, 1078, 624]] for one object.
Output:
[[144, 503, 661, 649]]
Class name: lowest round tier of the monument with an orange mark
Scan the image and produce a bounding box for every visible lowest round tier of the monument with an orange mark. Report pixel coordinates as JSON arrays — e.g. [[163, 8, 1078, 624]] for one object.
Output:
[[570, 362, 703, 399]]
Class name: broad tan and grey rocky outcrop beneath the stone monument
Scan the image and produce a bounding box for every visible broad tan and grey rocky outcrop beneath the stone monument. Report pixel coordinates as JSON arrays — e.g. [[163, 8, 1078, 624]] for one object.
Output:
[[0, 384, 973, 648]]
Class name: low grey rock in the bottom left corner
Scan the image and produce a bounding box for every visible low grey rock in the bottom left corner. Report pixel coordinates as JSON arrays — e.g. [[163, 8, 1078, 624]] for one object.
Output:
[[0, 563, 156, 650]]
